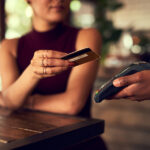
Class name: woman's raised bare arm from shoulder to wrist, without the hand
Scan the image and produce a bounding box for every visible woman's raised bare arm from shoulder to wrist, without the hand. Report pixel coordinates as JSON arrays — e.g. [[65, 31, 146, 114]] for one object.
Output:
[[0, 39, 38, 109]]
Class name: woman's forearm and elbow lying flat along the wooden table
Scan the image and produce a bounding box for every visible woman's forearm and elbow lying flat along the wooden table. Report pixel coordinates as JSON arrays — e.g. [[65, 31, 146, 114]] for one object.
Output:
[[27, 91, 86, 115]]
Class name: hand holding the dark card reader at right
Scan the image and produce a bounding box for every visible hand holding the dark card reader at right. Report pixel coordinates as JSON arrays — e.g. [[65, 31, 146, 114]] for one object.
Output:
[[111, 70, 150, 101]]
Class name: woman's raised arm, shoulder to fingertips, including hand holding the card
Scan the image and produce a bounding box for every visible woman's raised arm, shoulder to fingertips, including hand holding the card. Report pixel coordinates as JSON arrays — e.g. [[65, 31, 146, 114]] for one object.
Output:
[[0, 40, 69, 109]]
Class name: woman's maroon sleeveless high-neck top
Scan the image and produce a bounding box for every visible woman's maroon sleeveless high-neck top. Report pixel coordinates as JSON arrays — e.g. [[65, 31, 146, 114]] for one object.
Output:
[[17, 24, 90, 117]]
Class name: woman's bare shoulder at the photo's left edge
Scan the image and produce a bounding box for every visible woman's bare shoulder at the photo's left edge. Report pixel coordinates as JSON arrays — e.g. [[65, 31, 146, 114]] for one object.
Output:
[[0, 38, 19, 56]]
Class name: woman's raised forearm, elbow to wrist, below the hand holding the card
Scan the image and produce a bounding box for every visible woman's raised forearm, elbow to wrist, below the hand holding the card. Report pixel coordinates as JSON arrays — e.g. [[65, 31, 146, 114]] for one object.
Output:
[[2, 65, 39, 109]]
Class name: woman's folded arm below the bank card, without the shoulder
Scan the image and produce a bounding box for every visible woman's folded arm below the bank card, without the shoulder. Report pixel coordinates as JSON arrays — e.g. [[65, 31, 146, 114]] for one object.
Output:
[[29, 61, 98, 115]]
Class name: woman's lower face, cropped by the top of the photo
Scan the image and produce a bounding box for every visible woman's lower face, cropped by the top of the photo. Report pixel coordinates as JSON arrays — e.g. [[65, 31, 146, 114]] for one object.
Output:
[[28, 0, 70, 23]]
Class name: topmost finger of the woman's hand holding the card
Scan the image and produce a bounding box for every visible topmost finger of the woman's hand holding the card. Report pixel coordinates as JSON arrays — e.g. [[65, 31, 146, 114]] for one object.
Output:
[[34, 50, 67, 58]]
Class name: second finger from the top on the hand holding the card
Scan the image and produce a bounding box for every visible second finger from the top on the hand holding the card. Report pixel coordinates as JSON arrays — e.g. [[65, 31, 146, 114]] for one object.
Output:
[[31, 58, 70, 67]]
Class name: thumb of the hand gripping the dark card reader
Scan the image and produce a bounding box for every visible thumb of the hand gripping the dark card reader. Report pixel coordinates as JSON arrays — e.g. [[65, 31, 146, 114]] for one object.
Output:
[[113, 71, 143, 87]]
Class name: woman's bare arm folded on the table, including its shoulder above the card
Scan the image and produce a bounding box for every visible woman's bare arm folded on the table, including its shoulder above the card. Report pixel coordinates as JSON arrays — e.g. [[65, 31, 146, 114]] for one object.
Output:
[[26, 29, 101, 115]]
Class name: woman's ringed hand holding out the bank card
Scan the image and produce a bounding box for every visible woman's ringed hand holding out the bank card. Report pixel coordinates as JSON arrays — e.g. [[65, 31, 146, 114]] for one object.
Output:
[[31, 50, 73, 78]]
